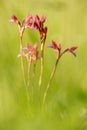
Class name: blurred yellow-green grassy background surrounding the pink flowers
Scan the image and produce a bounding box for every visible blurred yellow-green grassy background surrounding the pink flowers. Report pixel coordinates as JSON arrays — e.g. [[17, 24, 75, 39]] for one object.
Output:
[[0, 0, 87, 130]]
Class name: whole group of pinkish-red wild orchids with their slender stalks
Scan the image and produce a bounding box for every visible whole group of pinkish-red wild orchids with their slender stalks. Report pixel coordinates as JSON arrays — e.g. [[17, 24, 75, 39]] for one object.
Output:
[[9, 15, 77, 104]]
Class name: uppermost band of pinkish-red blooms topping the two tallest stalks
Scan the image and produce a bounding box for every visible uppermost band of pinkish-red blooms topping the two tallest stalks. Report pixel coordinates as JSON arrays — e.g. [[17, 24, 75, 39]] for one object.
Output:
[[9, 15, 47, 43]]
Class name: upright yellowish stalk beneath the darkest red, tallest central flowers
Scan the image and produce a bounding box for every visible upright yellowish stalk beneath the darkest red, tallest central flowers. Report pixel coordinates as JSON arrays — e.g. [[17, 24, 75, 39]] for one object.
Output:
[[39, 43, 44, 91]]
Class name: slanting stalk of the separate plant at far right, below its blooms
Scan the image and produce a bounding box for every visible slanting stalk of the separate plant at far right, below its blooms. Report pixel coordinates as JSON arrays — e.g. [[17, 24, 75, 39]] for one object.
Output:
[[43, 57, 60, 104]]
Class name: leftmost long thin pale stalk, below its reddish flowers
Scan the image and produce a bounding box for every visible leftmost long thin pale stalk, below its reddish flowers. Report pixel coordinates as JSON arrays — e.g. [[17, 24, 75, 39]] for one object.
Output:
[[20, 36, 29, 101]]
